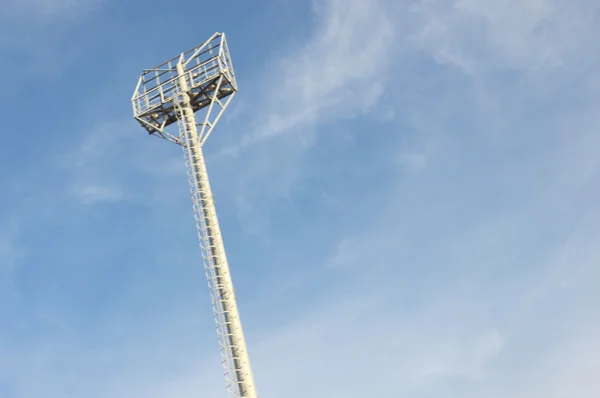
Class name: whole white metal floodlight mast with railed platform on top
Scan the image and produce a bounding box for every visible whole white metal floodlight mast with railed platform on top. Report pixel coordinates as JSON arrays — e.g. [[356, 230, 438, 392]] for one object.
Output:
[[132, 33, 258, 398]]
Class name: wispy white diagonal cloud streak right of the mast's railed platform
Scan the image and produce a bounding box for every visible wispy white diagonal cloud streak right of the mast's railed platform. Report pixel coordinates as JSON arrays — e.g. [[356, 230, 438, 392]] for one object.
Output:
[[256, 0, 394, 138]]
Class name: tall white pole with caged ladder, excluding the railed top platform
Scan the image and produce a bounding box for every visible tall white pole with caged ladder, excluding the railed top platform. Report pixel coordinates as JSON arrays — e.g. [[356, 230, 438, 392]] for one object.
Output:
[[174, 60, 258, 398]]
